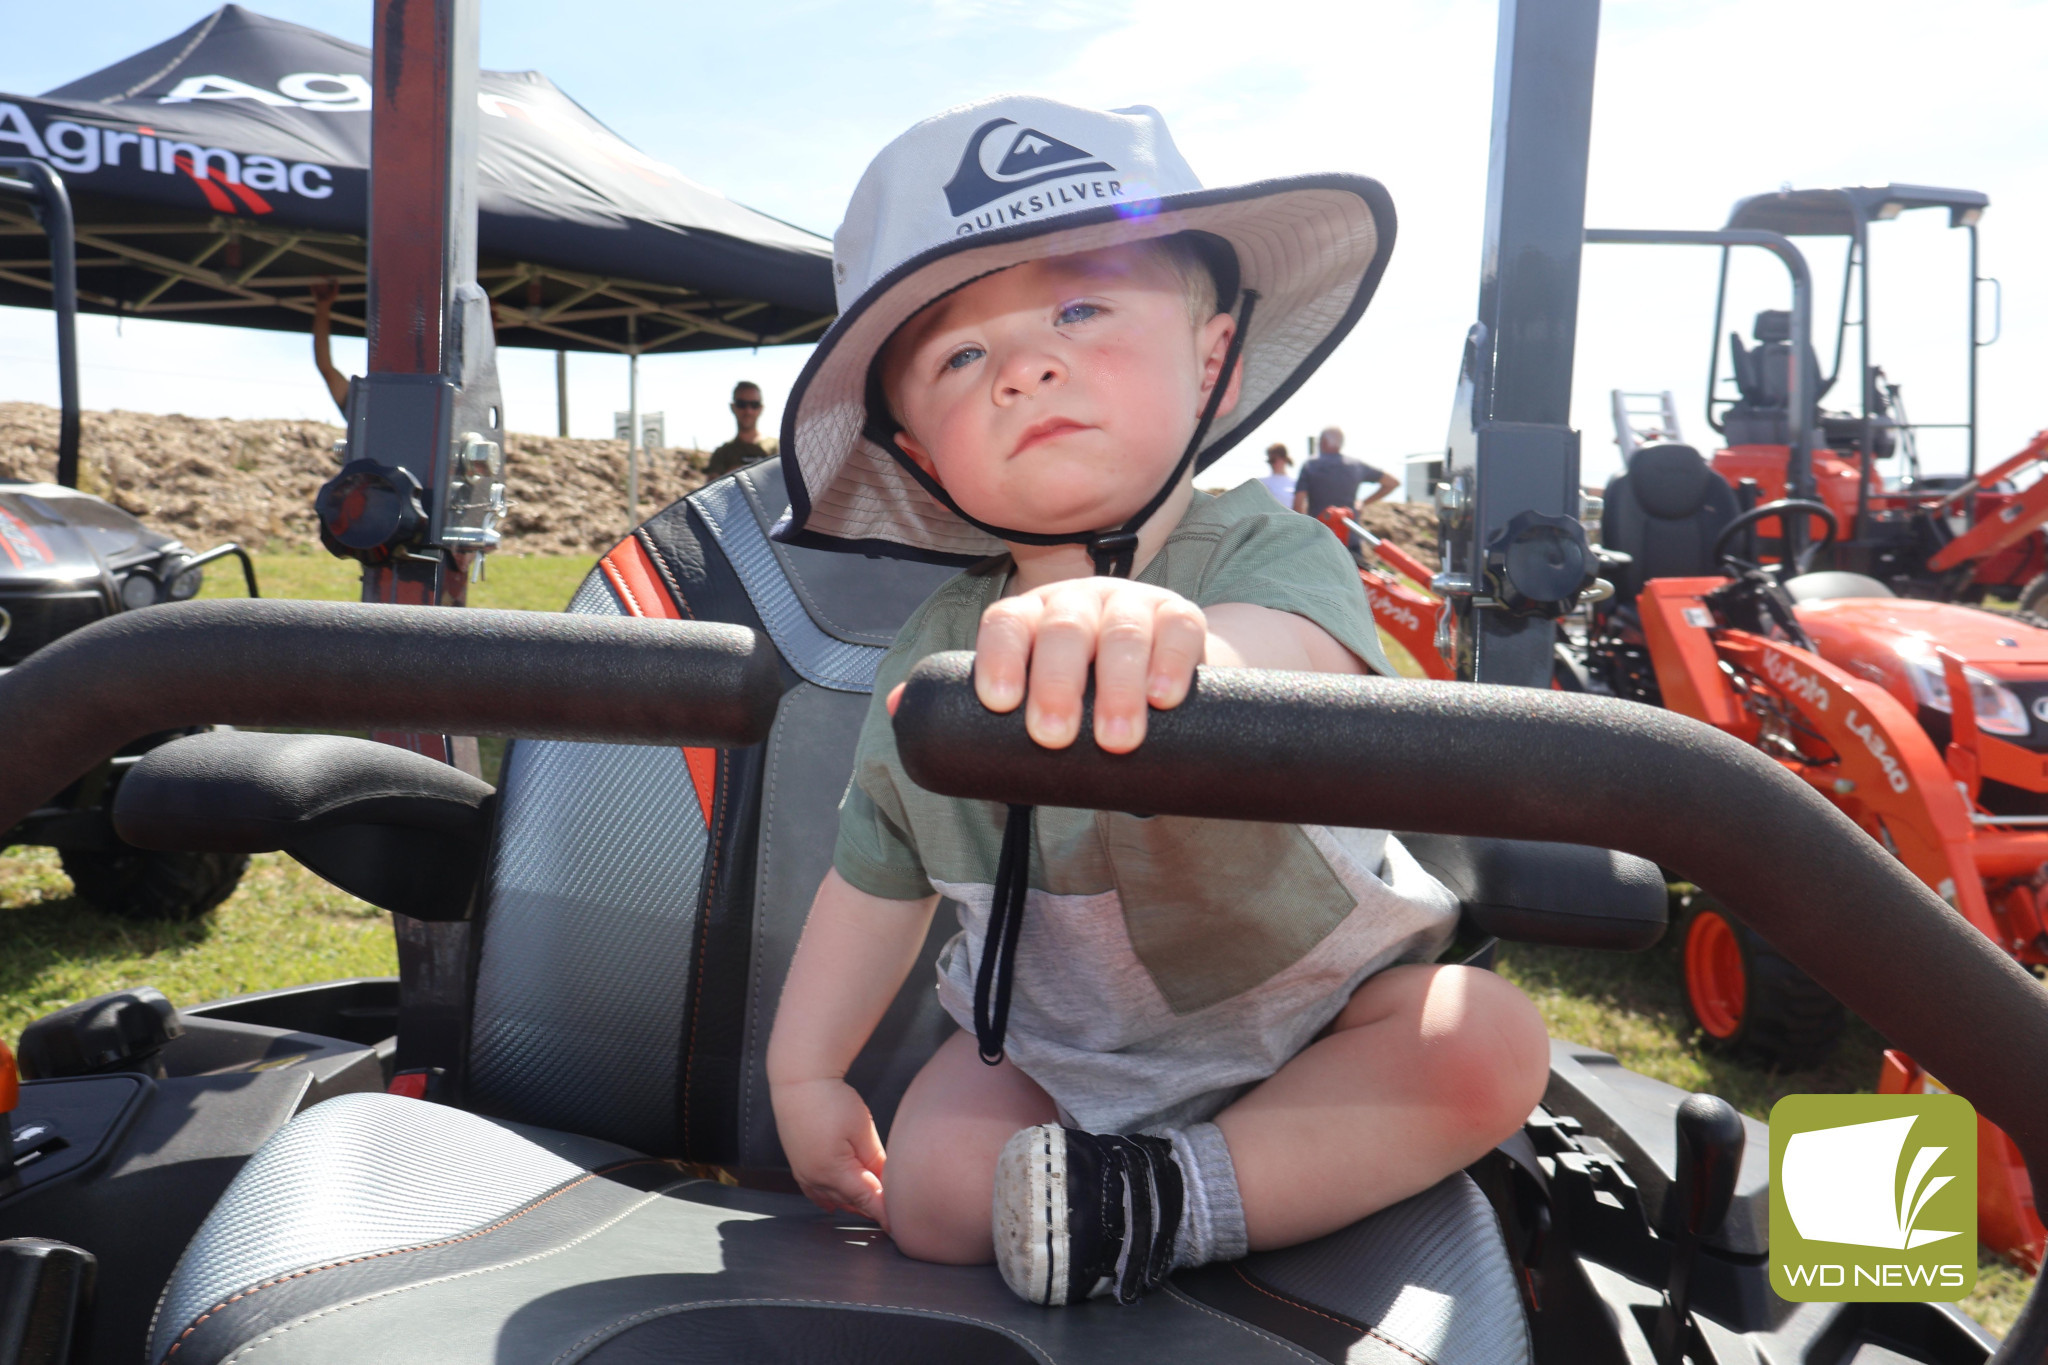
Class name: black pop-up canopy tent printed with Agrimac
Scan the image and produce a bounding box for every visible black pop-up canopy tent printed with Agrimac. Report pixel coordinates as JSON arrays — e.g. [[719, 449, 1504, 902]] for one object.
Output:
[[0, 4, 834, 354]]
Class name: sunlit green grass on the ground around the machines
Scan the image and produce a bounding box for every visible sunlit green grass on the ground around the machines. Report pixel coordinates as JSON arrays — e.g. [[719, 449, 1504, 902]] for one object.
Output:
[[0, 555, 2032, 1332]]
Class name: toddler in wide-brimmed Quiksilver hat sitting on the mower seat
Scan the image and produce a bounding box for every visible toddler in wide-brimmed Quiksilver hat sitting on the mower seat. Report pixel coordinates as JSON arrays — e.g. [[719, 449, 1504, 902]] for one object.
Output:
[[768, 96, 1548, 1304]]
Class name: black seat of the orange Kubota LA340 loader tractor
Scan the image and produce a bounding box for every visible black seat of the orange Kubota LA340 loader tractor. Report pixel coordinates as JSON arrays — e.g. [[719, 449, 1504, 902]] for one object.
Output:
[[1599, 444, 1737, 602]]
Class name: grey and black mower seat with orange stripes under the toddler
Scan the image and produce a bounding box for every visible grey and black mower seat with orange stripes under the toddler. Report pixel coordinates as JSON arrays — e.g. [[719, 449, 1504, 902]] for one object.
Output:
[[147, 467, 1530, 1365]]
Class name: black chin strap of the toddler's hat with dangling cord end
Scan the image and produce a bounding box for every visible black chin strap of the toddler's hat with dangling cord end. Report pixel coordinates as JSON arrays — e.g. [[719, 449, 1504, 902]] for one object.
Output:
[[970, 289, 1257, 1064]]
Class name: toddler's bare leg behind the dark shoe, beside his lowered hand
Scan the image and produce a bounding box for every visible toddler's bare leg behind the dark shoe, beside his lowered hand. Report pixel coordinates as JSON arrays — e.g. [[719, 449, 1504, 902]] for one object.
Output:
[[883, 1033, 1059, 1265]]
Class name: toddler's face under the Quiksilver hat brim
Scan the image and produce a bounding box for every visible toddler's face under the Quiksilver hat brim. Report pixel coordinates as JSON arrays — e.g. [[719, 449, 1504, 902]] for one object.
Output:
[[883, 246, 1237, 534]]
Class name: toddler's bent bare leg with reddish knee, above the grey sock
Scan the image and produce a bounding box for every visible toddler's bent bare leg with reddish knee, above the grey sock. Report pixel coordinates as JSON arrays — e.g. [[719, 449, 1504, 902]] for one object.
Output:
[[1204, 966, 1550, 1250]]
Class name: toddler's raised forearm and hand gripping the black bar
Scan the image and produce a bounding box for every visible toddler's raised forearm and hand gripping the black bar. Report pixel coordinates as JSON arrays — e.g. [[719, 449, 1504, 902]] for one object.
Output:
[[954, 577, 1366, 753]]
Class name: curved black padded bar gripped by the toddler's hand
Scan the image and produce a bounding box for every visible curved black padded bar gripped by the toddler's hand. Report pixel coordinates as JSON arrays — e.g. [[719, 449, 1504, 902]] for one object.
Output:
[[895, 653, 2048, 1363]]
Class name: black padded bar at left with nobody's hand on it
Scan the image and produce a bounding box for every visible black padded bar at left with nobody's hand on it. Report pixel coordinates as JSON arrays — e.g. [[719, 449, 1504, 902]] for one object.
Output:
[[0, 598, 782, 829]]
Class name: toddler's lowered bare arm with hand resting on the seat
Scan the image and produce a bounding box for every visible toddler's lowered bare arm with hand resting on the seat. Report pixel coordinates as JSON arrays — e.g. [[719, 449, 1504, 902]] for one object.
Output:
[[768, 870, 938, 1226]]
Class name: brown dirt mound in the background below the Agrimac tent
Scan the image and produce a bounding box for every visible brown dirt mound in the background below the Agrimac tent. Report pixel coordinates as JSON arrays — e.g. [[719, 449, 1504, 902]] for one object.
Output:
[[0, 403, 707, 555]]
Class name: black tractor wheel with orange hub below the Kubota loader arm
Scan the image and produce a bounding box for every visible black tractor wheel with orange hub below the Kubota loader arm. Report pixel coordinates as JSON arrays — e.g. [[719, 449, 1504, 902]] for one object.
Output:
[[1679, 900, 1845, 1068]]
